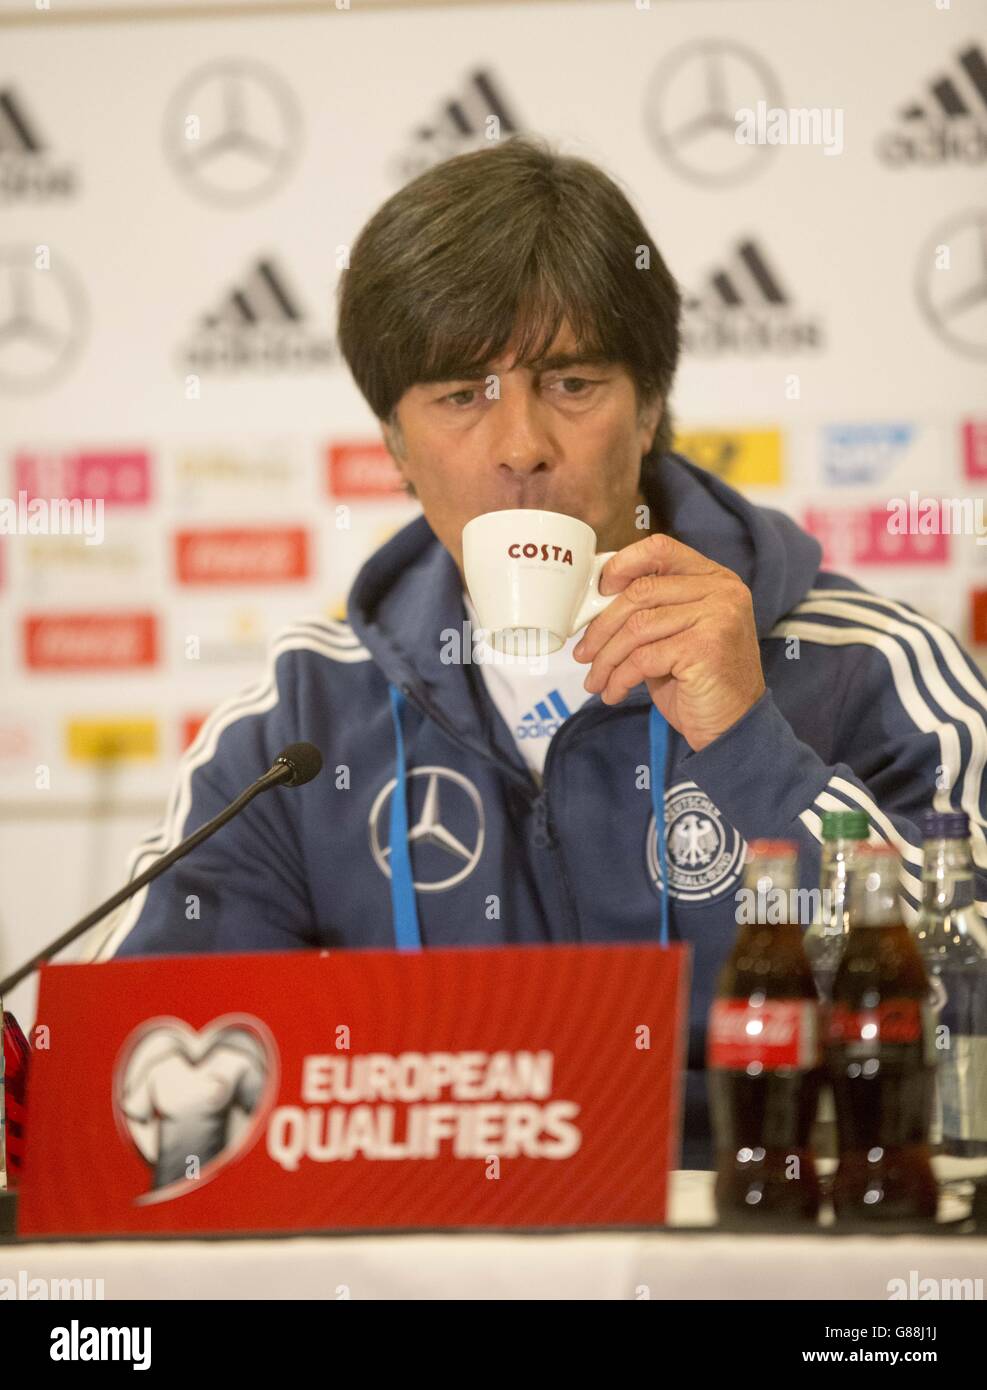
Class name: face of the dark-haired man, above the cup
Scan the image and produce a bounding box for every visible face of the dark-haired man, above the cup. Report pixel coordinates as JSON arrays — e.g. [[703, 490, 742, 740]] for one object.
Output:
[[384, 324, 660, 574]]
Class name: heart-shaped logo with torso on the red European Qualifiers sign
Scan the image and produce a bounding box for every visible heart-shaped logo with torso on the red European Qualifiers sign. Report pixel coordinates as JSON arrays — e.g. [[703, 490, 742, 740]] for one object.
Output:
[[113, 1013, 281, 1204]]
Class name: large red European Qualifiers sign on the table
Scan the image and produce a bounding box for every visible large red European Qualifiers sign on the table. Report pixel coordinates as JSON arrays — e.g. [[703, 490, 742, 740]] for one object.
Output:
[[18, 945, 688, 1236]]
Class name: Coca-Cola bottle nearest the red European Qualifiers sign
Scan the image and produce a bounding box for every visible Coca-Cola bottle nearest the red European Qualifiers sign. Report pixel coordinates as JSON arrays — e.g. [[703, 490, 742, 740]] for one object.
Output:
[[706, 840, 823, 1229]]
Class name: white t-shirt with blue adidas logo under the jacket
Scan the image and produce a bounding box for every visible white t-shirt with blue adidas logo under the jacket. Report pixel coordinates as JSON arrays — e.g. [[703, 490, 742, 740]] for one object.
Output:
[[463, 594, 589, 781]]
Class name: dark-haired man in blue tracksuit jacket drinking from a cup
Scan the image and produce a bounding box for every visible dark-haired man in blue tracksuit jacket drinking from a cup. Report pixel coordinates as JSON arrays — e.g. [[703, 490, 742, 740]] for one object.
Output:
[[99, 139, 987, 1166]]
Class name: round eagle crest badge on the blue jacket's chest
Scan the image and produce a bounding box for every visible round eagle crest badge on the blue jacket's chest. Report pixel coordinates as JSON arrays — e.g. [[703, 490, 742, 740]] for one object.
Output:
[[646, 781, 747, 904]]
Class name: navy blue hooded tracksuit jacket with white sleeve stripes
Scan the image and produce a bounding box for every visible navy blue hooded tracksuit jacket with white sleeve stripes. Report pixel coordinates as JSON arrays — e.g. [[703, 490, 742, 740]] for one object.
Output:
[[96, 455, 987, 1166]]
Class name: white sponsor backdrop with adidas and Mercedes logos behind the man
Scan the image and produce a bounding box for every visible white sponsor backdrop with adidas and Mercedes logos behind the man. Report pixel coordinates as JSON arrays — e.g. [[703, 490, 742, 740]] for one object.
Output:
[[0, 0, 987, 1016]]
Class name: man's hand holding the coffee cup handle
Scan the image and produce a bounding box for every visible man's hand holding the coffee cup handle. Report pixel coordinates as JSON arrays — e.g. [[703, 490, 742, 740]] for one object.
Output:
[[573, 535, 766, 752]]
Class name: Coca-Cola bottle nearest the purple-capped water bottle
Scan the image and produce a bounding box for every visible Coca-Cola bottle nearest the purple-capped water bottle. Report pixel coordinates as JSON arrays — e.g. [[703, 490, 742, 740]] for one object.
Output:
[[826, 845, 937, 1223]]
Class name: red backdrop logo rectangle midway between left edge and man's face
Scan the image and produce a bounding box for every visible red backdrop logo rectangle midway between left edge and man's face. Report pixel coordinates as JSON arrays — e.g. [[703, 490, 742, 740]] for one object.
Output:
[[175, 527, 309, 584]]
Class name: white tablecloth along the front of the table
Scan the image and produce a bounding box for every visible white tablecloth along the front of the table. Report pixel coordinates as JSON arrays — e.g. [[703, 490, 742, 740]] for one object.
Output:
[[0, 1173, 987, 1300]]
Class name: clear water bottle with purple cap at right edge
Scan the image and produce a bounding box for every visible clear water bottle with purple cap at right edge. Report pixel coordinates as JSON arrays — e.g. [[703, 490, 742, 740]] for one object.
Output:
[[912, 810, 987, 1158]]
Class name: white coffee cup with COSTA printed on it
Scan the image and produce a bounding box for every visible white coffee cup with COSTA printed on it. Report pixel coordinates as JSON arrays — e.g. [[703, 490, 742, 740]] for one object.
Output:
[[463, 507, 617, 656]]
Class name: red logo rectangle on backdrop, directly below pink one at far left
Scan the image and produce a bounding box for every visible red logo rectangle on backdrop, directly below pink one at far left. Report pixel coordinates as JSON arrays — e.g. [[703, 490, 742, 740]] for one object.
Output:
[[24, 613, 157, 671]]
